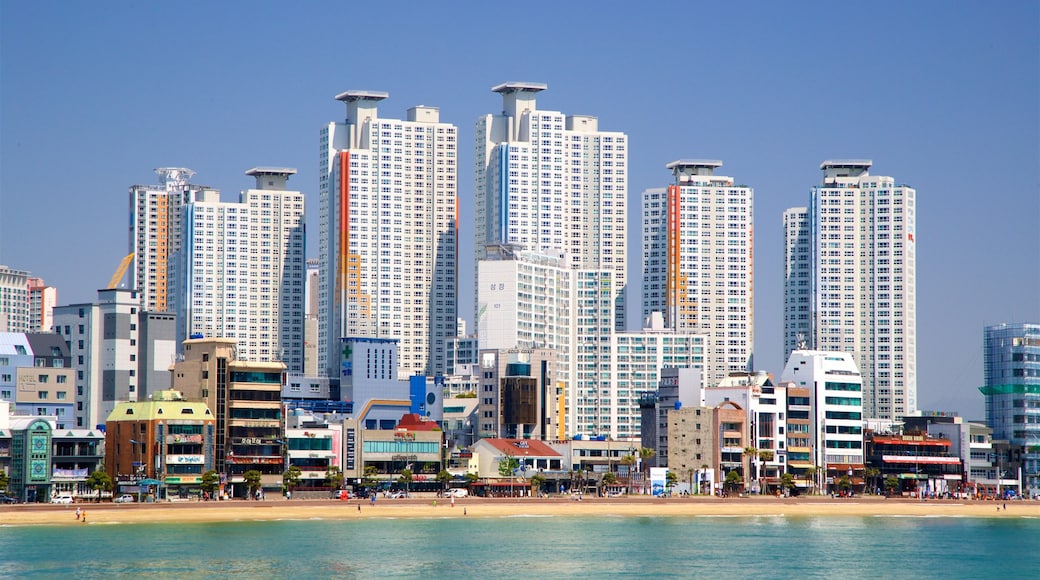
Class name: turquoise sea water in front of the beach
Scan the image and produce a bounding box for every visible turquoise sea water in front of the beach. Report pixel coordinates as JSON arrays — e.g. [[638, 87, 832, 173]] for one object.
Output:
[[0, 517, 1040, 579]]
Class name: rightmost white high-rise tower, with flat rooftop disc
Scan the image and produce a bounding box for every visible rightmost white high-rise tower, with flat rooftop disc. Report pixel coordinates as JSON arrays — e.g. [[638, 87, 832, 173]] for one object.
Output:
[[784, 160, 917, 420]]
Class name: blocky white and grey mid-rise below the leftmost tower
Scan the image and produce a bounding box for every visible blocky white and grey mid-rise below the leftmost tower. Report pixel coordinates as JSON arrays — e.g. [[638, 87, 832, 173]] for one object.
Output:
[[54, 288, 177, 428]]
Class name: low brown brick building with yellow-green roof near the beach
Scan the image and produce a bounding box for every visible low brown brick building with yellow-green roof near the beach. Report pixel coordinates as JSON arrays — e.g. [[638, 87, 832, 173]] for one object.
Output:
[[105, 390, 216, 500]]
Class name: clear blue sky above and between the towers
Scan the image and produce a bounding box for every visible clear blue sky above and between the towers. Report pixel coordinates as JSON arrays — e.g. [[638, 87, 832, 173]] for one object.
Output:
[[0, 0, 1040, 419]]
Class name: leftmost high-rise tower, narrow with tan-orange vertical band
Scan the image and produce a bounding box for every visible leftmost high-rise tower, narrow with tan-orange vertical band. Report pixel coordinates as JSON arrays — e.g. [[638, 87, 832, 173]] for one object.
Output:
[[129, 167, 213, 312]]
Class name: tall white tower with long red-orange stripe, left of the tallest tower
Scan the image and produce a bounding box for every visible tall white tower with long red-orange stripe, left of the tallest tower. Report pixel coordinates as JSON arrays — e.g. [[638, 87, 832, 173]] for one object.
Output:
[[318, 90, 458, 378]]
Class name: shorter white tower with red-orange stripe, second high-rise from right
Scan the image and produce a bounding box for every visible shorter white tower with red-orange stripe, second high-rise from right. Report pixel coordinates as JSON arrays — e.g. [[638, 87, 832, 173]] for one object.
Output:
[[643, 159, 755, 386]]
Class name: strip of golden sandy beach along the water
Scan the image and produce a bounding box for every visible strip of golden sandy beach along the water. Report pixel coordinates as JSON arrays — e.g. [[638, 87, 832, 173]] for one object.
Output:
[[0, 497, 1040, 526]]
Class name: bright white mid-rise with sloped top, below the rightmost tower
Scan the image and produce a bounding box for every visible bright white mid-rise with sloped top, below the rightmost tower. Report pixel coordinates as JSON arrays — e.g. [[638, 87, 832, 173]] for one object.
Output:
[[780, 350, 863, 489]]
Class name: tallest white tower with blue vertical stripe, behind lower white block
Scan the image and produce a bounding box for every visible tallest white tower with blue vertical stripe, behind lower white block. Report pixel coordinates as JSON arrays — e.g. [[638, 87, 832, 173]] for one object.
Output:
[[474, 82, 628, 329]]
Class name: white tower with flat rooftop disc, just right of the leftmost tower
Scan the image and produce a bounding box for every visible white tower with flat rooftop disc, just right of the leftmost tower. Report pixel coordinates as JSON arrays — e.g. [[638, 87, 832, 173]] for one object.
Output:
[[177, 167, 306, 373]]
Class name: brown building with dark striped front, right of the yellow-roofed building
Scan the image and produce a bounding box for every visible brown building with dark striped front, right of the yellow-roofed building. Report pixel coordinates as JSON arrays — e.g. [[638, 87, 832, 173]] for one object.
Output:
[[171, 338, 285, 497]]
